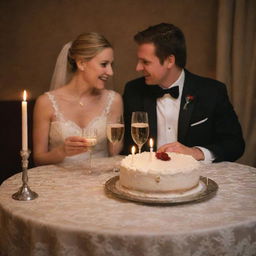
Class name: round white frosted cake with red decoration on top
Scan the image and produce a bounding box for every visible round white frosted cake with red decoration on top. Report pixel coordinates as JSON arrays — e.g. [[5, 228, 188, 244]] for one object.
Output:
[[119, 152, 200, 193]]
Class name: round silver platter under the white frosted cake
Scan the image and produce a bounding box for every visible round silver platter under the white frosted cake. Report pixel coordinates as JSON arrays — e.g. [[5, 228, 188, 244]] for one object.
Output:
[[105, 176, 218, 205]]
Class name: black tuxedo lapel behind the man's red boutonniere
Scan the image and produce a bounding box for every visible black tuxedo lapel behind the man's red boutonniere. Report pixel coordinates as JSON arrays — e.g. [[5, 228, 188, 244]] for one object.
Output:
[[178, 71, 196, 144]]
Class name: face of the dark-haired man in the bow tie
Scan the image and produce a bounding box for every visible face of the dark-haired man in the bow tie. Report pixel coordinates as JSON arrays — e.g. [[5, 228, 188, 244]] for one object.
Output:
[[136, 43, 169, 86]]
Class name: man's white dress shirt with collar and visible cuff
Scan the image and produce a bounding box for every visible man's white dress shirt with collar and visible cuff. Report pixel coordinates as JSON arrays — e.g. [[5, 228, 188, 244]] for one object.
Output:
[[156, 70, 214, 163]]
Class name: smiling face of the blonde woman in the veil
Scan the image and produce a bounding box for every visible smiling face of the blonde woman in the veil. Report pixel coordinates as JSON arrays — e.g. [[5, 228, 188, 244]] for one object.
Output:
[[82, 48, 114, 89]]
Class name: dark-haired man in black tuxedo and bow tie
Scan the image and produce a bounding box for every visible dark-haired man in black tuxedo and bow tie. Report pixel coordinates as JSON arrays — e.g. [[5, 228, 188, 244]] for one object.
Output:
[[123, 23, 245, 163]]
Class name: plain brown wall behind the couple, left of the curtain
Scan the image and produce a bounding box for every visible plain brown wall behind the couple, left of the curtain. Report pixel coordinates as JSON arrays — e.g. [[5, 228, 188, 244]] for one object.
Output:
[[0, 0, 218, 100]]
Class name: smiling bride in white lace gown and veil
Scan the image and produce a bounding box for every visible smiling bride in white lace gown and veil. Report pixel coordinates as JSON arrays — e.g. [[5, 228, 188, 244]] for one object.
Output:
[[33, 33, 123, 165]]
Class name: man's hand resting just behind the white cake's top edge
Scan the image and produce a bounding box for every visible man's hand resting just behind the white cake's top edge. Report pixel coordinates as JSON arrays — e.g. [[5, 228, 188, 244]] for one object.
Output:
[[157, 142, 204, 161]]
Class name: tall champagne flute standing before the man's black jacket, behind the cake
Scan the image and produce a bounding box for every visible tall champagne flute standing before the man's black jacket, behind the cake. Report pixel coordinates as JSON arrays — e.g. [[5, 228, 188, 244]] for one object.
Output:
[[131, 111, 149, 153]]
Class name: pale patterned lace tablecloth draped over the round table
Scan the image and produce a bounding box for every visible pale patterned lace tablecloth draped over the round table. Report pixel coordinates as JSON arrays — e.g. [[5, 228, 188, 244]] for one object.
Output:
[[0, 158, 256, 256]]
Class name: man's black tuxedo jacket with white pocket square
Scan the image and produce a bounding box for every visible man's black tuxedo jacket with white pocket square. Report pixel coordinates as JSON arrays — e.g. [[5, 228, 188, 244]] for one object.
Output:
[[123, 70, 245, 162]]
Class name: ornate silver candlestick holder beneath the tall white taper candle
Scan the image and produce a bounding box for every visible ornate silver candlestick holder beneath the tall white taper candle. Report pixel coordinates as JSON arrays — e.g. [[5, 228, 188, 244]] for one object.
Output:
[[12, 150, 38, 201]]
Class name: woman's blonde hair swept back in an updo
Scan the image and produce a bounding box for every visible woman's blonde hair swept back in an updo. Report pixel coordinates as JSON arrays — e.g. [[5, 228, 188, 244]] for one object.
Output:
[[68, 32, 112, 72]]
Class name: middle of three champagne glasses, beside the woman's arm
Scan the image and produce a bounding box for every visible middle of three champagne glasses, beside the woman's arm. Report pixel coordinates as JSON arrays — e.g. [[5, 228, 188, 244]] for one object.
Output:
[[107, 115, 124, 172]]
